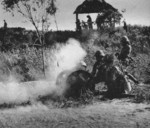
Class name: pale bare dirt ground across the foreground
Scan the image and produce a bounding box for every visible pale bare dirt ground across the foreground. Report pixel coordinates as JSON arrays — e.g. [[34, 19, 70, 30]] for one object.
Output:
[[0, 99, 150, 128]]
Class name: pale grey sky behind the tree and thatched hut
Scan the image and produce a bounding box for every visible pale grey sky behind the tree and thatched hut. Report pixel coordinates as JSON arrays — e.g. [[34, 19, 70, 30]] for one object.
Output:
[[0, 0, 150, 30]]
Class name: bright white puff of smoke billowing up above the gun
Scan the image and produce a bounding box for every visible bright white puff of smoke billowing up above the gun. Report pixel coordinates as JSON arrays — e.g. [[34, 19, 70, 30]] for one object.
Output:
[[48, 39, 86, 79]]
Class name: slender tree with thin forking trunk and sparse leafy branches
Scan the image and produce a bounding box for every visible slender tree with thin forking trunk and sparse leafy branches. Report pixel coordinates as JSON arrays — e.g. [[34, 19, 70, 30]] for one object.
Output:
[[2, 0, 57, 73]]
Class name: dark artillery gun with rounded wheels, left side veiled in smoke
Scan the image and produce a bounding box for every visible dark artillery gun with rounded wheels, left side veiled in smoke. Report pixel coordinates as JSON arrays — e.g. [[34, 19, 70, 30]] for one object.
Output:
[[56, 69, 95, 98]]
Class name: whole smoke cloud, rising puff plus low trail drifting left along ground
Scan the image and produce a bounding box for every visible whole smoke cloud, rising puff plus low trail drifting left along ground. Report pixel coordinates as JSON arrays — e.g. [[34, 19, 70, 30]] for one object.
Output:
[[0, 39, 86, 104]]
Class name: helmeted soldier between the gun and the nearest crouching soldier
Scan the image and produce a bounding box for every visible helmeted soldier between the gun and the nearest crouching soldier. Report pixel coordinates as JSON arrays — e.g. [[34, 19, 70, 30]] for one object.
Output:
[[92, 50, 105, 83]]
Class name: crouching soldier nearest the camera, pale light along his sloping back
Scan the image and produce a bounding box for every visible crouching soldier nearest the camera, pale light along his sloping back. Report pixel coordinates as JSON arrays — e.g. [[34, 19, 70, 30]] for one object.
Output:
[[104, 55, 131, 97]]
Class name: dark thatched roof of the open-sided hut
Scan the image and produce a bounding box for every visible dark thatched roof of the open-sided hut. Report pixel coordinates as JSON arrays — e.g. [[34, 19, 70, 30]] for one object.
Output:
[[74, 0, 118, 14]]
